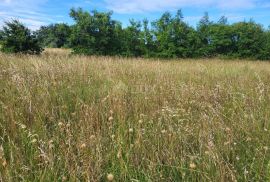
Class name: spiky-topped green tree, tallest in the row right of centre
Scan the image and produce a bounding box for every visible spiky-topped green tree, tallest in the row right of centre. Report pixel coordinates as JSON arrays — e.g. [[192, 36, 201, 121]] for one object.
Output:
[[154, 10, 197, 58]]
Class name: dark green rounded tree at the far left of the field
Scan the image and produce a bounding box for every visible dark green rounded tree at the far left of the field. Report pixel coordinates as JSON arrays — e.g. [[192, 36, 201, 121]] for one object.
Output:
[[0, 20, 43, 54]]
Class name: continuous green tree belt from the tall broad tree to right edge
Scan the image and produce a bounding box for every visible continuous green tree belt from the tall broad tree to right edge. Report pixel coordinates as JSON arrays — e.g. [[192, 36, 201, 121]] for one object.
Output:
[[63, 9, 270, 59]]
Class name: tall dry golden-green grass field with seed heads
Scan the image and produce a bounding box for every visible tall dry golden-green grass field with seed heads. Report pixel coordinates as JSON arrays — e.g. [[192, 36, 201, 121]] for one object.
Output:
[[0, 51, 270, 182]]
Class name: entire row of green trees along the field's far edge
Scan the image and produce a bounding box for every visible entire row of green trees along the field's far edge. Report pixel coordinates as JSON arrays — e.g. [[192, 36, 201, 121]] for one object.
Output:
[[0, 8, 270, 60]]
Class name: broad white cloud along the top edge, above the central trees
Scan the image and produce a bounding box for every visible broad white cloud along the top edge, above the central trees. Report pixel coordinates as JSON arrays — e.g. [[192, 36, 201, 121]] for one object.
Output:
[[105, 0, 260, 13]]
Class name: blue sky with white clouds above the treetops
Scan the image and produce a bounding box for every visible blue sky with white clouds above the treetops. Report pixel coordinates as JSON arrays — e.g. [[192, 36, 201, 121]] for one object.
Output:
[[0, 0, 270, 30]]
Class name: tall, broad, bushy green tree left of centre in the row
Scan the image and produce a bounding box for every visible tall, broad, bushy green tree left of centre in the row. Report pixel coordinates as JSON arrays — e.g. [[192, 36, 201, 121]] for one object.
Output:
[[70, 8, 121, 55]]
